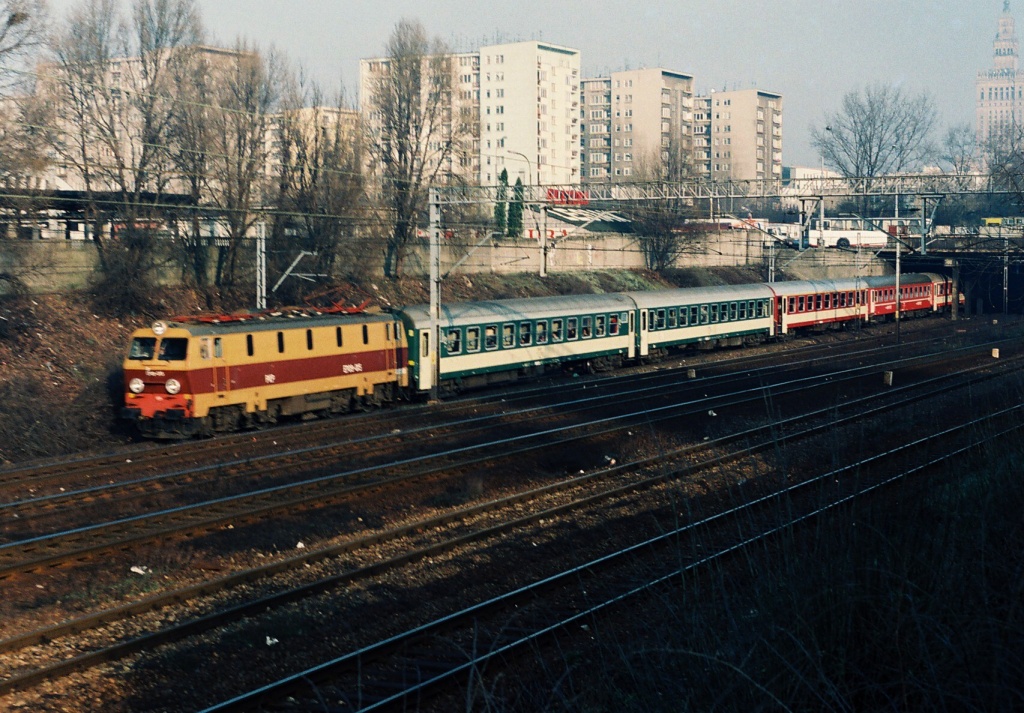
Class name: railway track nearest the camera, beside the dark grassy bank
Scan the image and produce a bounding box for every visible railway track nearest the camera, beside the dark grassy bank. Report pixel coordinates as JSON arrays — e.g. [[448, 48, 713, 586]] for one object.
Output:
[[190, 406, 1021, 713]]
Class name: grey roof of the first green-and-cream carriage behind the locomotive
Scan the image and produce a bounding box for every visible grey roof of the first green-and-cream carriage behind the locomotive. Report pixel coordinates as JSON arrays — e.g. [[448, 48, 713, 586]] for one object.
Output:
[[398, 294, 635, 328]]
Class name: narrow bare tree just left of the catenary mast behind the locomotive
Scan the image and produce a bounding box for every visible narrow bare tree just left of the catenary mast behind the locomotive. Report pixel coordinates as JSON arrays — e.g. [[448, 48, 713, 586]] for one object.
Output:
[[201, 41, 284, 286]]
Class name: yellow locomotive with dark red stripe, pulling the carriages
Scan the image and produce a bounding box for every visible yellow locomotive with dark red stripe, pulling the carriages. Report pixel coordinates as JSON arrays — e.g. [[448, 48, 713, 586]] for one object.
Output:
[[122, 309, 408, 437]]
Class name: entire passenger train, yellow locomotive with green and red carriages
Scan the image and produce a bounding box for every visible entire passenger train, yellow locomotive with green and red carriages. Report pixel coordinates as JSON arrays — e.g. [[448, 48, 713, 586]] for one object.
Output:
[[122, 274, 953, 438]]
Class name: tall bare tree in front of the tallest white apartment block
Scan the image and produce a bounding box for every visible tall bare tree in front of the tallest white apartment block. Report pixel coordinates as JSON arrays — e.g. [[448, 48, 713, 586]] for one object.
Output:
[[369, 19, 467, 277]]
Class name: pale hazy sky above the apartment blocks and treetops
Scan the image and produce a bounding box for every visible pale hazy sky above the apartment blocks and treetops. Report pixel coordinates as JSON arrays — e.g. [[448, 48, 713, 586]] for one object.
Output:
[[49, 0, 1007, 166]]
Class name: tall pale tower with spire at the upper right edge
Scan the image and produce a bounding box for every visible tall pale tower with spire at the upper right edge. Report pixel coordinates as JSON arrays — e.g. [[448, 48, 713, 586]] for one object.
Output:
[[975, 0, 1024, 153]]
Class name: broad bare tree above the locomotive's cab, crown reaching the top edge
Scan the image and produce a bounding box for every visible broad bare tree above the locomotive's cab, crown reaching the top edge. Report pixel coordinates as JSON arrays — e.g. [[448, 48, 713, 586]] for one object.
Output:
[[43, 0, 202, 307]]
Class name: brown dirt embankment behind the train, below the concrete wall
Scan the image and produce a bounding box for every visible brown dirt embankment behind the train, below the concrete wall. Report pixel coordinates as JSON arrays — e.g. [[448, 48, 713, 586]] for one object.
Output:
[[0, 269, 760, 467]]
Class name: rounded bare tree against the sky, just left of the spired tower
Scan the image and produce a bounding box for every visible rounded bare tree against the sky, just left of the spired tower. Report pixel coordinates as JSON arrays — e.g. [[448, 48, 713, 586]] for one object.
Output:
[[811, 84, 937, 178]]
